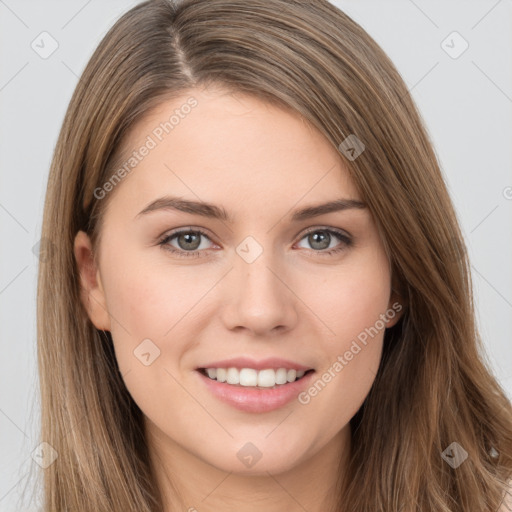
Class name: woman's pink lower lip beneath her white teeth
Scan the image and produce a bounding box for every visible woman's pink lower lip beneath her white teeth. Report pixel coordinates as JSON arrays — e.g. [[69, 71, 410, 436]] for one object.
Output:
[[197, 371, 315, 413]]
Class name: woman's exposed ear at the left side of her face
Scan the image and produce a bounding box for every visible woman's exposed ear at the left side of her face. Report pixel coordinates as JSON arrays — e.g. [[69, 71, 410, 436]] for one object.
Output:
[[73, 231, 110, 331]]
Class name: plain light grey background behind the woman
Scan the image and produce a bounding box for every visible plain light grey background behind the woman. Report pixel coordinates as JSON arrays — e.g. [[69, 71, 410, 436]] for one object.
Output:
[[0, 0, 512, 512]]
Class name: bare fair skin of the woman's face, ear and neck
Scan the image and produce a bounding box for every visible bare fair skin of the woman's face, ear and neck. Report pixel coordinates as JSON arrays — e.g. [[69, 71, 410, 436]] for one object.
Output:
[[75, 85, 400, 512]]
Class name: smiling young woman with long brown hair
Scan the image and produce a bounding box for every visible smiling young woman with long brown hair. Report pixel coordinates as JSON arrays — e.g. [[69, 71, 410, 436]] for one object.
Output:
[[38, 0, 512, 512]]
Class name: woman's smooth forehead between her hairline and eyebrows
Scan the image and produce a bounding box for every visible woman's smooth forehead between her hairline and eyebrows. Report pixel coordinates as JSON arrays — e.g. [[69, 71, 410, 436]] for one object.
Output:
[[105, 89, 359, 215]]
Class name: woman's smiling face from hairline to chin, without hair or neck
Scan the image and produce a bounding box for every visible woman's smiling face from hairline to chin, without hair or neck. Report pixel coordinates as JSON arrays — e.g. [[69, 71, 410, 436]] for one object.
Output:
[[75, 85, 399, 474]]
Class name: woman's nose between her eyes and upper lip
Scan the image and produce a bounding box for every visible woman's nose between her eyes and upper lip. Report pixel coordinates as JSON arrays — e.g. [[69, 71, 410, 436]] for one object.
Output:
[[221, 251, 298, 337]]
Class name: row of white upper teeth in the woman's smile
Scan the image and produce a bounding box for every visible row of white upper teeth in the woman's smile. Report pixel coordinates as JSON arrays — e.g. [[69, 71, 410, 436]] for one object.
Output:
[[201, 368, 306, 388]]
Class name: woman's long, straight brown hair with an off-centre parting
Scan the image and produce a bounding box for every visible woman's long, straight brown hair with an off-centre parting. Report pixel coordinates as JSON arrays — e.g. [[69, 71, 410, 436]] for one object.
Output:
[[38, 0, 512, 512]]
